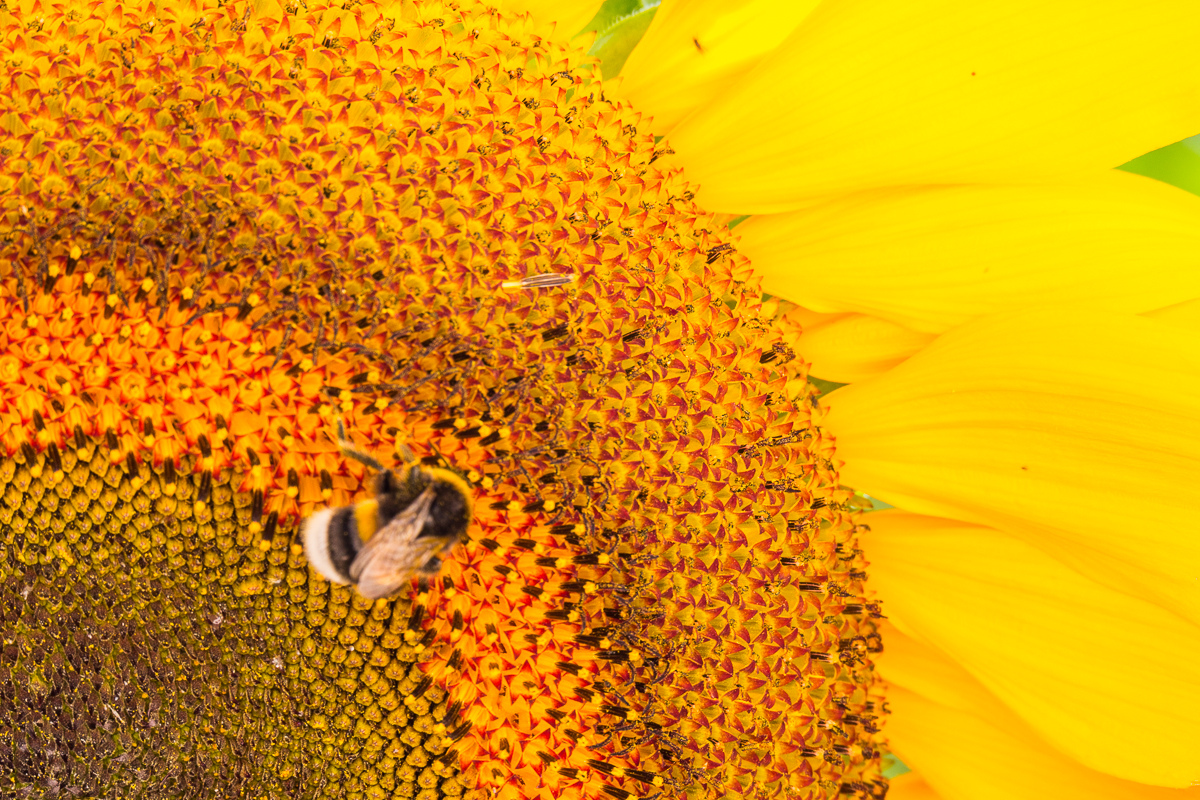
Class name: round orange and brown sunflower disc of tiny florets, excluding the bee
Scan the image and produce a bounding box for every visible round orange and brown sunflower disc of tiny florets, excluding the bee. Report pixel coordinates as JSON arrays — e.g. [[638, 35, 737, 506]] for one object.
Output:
[[0, 0, 886, 800]]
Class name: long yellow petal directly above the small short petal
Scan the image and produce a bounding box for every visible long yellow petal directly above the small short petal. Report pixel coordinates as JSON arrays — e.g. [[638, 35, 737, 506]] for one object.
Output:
[[737, 170, 1200, 335]]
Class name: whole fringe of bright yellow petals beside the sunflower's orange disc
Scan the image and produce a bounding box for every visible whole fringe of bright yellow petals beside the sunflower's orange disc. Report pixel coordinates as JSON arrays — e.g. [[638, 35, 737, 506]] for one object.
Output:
[[609, 1, 1200, 798]]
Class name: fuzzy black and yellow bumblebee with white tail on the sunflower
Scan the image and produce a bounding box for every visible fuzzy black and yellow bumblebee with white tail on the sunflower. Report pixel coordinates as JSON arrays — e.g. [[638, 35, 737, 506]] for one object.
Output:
[[304, 420, 472, 600]]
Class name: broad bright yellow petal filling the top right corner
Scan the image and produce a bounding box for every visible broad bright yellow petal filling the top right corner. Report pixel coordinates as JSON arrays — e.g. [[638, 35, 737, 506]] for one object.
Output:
[[670, 0, 1200, 213]]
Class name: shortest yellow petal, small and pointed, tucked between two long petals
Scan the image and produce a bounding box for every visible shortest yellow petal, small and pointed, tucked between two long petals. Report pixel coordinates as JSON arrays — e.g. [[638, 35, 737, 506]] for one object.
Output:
[[796, 314, 935, 384]]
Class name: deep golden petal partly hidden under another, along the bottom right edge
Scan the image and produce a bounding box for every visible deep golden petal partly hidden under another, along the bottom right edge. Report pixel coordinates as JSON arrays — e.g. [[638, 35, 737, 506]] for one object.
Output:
[[878, 627, 1195, 800]]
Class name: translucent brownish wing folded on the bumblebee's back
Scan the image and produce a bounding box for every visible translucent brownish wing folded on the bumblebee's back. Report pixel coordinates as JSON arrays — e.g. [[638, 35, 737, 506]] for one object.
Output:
[[350, 488, 446, 600]]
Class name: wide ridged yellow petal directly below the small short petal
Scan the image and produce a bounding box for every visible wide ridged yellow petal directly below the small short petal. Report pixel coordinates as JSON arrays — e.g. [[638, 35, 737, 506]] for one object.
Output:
[[827, 309, 1200, 622]]
